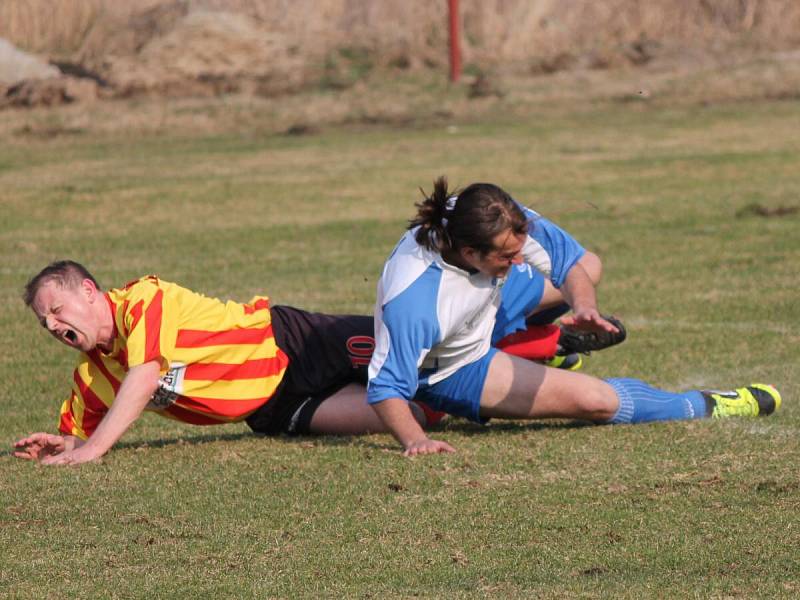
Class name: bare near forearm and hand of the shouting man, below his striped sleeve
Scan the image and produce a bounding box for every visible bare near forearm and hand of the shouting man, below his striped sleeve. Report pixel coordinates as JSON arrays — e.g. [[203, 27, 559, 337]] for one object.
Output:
[[42, 361, 160, 465]]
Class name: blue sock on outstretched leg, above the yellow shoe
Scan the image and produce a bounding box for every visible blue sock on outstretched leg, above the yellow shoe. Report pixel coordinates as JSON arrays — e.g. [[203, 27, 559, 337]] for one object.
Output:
[[606, 379, 706, 423]]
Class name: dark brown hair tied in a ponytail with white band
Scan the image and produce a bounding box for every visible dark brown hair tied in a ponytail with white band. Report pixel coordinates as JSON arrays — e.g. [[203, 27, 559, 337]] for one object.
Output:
[[408, 177, 528, 255]]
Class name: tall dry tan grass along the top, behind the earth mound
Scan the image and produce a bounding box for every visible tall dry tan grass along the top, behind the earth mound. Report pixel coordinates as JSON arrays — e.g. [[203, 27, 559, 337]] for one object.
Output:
[[0, 0, 800, 62]]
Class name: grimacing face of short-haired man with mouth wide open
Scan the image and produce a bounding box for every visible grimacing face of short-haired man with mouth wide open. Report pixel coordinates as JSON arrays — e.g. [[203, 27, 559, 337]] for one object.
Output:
[[31, 279, 100, 352]]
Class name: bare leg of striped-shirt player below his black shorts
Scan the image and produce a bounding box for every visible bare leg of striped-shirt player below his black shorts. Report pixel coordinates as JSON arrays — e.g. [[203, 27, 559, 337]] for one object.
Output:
[[309, 383, 432, 435]]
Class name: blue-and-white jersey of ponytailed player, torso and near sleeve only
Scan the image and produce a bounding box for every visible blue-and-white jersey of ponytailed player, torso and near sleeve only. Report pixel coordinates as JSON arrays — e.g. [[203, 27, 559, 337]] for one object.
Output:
[[367, 229, 504, 404]]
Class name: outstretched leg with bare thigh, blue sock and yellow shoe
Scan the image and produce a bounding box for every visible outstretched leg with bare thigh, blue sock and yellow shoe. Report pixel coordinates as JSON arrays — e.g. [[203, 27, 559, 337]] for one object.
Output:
[[480, 352, 781, 423]]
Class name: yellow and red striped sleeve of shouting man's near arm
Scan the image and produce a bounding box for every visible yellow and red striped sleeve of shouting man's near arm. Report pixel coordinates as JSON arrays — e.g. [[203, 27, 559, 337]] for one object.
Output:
[[122, 278, 178, 371]]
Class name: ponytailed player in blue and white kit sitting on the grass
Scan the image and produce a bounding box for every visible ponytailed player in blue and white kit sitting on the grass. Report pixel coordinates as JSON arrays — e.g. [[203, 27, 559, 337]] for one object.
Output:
[[367, 178, 781, 456]]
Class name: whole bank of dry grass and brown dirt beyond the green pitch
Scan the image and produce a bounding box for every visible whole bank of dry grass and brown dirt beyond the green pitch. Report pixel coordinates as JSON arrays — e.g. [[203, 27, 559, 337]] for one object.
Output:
[[0, 0, 800, 136]]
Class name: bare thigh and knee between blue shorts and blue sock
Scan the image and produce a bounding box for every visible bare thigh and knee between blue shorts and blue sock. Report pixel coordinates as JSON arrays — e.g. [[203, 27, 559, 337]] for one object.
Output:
[[481, 352, 619, 422]]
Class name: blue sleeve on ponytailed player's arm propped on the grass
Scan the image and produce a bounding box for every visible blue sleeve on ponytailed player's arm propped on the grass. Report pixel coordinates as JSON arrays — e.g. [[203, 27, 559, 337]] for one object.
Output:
[[367, 272, 441, 404]]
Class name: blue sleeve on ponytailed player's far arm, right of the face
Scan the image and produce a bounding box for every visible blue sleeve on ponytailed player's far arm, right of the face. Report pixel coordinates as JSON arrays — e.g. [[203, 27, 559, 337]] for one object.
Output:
[[522, 207, 586, 288]]
